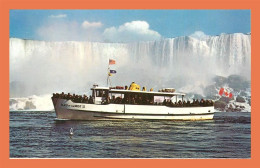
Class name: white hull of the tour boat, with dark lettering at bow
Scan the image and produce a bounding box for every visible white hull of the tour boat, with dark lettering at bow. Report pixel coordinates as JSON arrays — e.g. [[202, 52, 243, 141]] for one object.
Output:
[[53, 98, 214, 120]]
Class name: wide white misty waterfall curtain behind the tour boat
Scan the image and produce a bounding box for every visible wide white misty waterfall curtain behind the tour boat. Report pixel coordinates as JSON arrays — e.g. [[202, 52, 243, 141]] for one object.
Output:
[[9, 33, 251, 109]]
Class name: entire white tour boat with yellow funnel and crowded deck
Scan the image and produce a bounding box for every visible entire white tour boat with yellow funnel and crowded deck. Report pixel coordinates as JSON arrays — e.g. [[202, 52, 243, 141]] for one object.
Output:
[[52, 82, 214, 120]]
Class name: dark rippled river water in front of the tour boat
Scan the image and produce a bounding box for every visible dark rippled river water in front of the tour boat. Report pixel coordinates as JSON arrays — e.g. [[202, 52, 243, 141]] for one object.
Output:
[[10, 111, 251, 158]]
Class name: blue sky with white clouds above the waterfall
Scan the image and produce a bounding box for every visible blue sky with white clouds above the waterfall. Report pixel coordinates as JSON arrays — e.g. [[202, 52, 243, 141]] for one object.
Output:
[[9, 10, 251, 42]]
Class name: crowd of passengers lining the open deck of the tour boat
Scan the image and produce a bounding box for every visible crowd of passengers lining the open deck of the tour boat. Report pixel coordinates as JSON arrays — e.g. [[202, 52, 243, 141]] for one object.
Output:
[[53, 92, 214, 107]]
